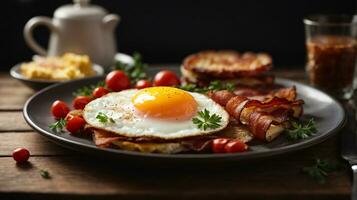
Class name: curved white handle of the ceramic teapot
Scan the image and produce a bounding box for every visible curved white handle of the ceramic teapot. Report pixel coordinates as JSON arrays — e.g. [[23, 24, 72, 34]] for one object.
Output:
[[24, 16, 57, 56]]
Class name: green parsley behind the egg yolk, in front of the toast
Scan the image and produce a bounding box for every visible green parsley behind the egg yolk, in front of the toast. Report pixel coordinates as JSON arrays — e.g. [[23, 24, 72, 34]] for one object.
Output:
[[179, 80, 235, 93]]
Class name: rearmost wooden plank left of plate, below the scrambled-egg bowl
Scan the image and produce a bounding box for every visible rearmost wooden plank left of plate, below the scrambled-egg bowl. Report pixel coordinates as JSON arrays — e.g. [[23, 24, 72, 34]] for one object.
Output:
[[0, 73, 34, 110]]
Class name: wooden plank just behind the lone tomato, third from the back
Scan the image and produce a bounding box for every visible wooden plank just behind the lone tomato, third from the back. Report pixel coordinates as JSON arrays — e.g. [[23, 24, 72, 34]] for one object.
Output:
[[0, 132, 71, 157]]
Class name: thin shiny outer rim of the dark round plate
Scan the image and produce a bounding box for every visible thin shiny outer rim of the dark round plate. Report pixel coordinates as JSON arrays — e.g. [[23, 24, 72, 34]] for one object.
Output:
[[23, 72, 346, 160]]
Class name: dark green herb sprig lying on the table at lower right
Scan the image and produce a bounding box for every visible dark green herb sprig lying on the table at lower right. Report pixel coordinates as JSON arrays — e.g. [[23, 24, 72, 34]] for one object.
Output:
[[302, 159, 341, 184]]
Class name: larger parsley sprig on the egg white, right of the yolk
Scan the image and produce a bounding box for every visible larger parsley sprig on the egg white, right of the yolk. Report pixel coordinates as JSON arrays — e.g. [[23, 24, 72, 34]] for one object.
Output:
[[192, 109, 222, 131]]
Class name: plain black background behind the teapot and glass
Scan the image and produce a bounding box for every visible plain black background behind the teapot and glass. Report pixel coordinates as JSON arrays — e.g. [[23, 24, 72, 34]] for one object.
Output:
[[0, 0, 356, 70]]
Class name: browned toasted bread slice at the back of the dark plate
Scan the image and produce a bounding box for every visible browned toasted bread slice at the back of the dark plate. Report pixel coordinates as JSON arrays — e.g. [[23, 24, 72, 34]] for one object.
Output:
[[183, 50, 272, 78]]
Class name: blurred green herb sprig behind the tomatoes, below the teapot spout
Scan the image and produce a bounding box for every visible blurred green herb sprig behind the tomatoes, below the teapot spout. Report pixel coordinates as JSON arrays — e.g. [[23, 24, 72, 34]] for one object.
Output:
[[114, 52, 148, 83]]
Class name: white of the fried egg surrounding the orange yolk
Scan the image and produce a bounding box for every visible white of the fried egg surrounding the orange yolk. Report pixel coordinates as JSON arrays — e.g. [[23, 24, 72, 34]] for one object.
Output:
[[83, 89, 229, 140]]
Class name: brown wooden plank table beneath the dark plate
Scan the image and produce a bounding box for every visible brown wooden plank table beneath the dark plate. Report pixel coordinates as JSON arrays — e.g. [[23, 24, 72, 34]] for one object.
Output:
[[0, 70, 351, 200]]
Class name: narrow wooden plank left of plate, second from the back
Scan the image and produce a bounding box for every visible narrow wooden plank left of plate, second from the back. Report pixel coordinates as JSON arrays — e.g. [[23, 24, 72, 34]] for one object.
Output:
[[0, 112, 32, 132]]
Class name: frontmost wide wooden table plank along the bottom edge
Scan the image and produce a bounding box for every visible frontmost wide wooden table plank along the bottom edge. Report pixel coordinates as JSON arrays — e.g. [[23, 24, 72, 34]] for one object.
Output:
[[0, 141, 351, 199]]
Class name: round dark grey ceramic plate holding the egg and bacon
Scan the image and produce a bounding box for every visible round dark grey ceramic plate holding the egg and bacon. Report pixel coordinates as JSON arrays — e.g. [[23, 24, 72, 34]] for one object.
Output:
[[24, 68, 345, 163]]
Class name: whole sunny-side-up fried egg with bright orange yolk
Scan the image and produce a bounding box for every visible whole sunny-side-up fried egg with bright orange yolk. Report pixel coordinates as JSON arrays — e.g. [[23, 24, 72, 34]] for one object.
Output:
[[83, 87, 229, 140]]
